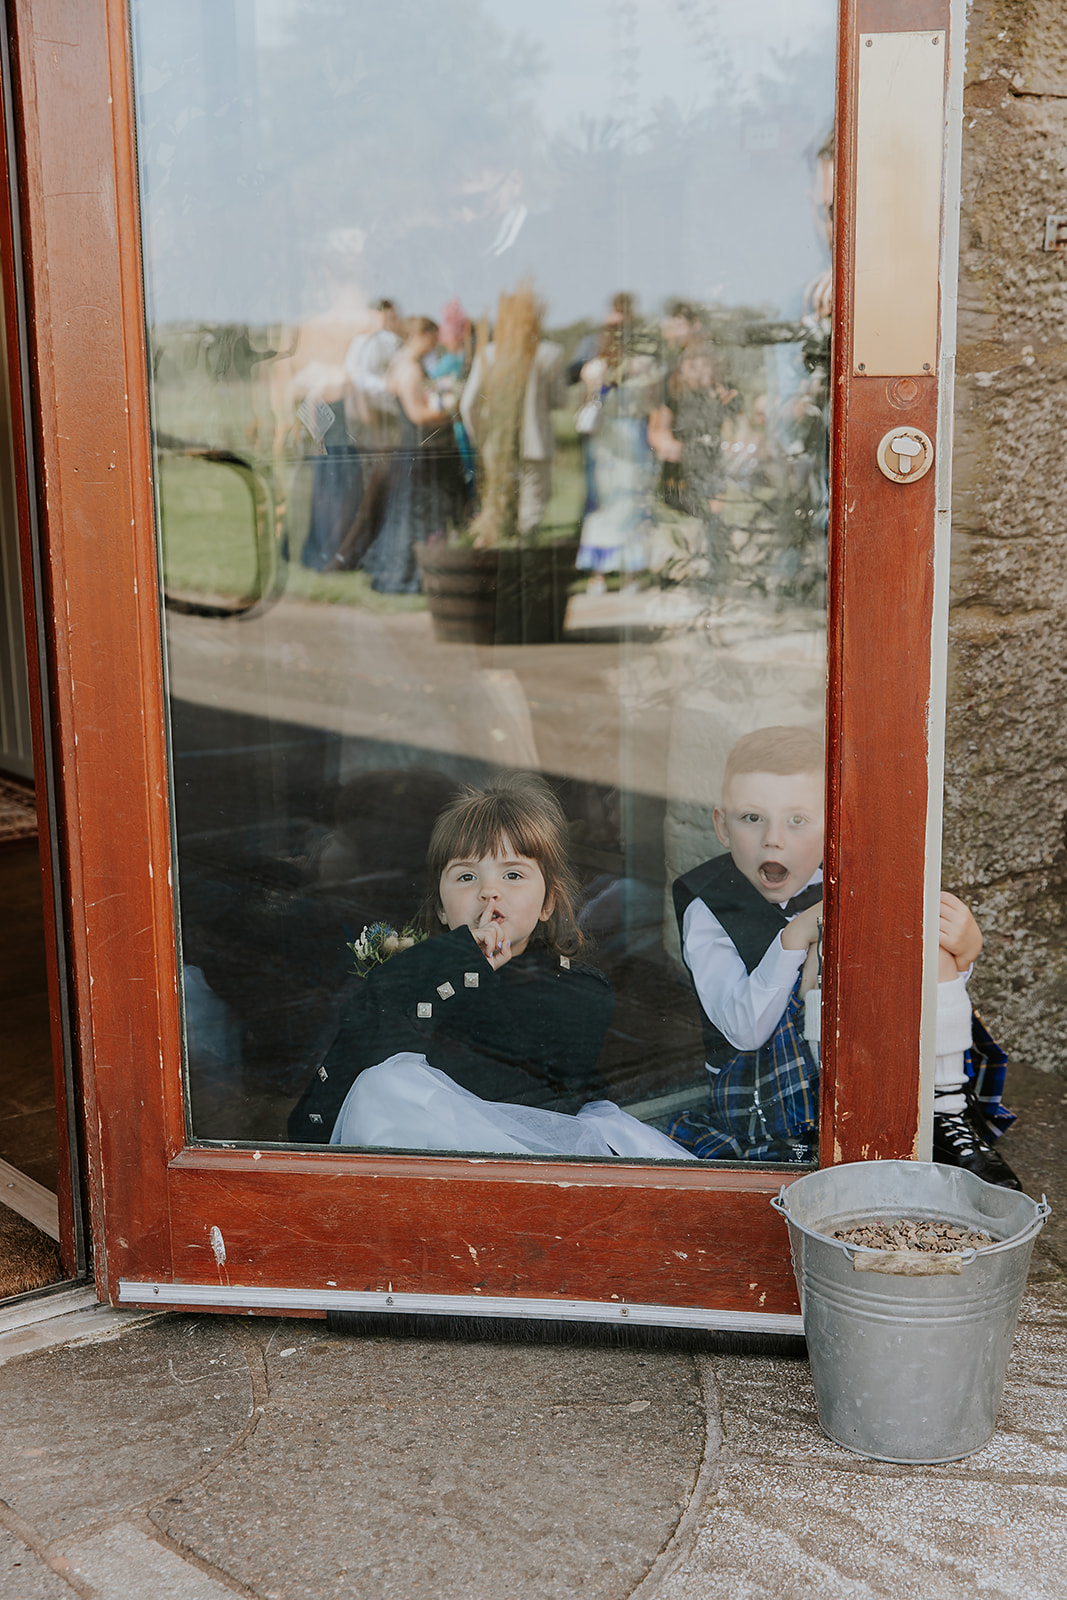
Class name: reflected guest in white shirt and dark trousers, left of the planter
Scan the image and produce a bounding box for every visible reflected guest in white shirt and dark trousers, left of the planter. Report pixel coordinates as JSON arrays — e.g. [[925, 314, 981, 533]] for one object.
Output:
[[326, 299, 402, 571]]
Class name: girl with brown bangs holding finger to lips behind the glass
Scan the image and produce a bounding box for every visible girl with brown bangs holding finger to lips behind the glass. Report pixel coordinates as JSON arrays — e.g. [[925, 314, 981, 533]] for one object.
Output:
[[290, 773, 689, 1160]]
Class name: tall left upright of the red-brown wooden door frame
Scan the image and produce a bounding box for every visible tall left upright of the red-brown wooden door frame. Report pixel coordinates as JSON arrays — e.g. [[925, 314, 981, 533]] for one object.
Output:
[[8, 0, 178, 1291]]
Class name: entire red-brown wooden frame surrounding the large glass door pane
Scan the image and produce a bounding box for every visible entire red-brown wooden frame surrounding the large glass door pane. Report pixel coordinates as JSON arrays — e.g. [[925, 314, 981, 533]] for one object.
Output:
[[8, 0, 949, 1326]]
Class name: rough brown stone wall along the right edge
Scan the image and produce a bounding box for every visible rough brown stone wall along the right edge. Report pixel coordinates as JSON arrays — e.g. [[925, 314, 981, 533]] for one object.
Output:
[[944, 0, 1067, 1075]]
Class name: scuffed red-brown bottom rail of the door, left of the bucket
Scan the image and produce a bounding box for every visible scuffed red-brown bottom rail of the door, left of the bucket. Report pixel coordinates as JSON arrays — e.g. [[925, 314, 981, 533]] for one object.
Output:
[[164, 1152, 798, 1312]]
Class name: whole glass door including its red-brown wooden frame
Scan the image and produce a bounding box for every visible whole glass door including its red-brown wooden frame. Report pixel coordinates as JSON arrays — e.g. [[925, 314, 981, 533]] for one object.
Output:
[[8, 0, 945, 1326]]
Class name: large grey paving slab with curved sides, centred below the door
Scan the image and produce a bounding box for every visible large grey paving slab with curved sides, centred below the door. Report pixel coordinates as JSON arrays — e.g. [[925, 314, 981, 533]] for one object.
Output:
[[150, 1323, 704, 1600]]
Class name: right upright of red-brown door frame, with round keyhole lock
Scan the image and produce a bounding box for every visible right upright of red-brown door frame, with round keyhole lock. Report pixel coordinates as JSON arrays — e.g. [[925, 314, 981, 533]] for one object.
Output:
[[821, 0, 947, 1163]]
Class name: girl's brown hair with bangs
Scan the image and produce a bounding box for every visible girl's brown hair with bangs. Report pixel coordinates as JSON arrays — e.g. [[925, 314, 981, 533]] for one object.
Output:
[[419, 773, 585, 955]]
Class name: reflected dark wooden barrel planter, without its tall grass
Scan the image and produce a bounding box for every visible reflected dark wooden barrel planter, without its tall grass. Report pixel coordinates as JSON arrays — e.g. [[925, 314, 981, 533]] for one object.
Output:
[[414, 541, 577, 645]]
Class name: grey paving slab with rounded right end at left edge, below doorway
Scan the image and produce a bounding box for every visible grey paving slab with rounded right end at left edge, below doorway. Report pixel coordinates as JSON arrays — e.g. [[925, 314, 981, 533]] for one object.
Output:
[[0, 1317, 253, 1541]]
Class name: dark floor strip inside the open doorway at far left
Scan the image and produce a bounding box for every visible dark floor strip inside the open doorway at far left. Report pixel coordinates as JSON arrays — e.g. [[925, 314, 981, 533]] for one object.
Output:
[[0, 840, 59, 1198]]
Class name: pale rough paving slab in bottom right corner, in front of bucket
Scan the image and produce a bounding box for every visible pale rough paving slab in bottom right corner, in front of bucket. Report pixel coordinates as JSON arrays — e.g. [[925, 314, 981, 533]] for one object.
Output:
[[656, 1461, 1067, 1600]]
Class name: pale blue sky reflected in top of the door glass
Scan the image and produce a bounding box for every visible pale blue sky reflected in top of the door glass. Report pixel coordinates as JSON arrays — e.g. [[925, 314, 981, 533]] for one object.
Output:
[[133, 0, 835, 325]]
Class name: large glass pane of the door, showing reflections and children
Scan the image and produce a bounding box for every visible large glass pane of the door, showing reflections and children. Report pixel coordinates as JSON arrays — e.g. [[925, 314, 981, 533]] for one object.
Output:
[[133, 0, 837, 1162]]
